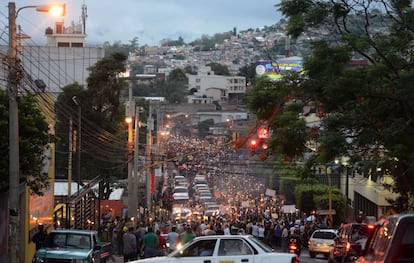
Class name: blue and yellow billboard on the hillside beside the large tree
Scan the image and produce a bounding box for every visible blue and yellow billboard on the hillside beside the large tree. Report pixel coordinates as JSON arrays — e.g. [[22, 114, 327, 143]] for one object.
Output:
[[256, 57, 304, 80]]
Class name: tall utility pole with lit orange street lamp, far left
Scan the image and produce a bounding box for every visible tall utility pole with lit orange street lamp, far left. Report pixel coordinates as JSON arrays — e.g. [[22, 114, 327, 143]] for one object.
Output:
[[7, 2, 65, 263]]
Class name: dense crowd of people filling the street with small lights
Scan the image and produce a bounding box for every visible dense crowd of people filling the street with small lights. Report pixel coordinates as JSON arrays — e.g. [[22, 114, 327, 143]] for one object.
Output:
[[108, 136, 332, 262]]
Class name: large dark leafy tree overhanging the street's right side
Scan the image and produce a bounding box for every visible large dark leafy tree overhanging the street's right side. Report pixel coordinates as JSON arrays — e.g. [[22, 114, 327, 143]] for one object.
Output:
[[251, 0, 414, 211]]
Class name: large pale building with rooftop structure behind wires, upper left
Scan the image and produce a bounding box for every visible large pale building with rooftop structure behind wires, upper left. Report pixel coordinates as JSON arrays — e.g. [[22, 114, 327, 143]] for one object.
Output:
[[0, 17, 105, 93]]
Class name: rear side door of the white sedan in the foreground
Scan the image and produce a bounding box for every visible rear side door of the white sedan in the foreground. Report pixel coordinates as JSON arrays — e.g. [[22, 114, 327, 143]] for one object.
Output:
[[211, 238, 254, 263]]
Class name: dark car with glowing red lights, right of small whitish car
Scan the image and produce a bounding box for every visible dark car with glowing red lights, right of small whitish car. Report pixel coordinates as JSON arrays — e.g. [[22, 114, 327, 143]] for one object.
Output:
[[328, 223, 374, 263]]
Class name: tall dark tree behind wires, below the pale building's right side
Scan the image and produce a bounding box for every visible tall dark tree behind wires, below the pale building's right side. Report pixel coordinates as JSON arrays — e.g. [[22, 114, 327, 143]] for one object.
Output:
[[56, 53, 127, 183]]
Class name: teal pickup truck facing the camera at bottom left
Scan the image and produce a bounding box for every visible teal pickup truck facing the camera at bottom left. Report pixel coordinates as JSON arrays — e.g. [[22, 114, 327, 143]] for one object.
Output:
[[32, 229, 111, 263]]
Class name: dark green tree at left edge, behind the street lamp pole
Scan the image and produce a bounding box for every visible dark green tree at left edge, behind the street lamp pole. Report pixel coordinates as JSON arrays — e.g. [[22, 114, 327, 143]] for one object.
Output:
[[0, 89, 54, 195]]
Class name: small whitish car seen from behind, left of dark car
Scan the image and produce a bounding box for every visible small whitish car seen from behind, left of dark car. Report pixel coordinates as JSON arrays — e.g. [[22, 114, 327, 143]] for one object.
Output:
[[308, 229, 338, 258]]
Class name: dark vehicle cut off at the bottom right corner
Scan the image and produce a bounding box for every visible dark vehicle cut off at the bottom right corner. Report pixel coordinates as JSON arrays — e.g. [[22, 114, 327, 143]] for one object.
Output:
[[355, 214, 414, 263]]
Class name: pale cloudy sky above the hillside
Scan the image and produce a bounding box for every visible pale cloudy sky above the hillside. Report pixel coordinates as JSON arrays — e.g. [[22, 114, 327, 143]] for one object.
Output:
[[6, 0, 281, 45]]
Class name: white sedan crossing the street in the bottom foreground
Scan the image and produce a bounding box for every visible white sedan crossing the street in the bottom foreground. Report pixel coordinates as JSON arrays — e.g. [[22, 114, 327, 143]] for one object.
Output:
[[134, 235, 299, 263]]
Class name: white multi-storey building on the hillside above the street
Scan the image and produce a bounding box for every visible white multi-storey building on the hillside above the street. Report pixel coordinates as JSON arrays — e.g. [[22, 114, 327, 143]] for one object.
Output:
[[187, 67, 246, 104]]
